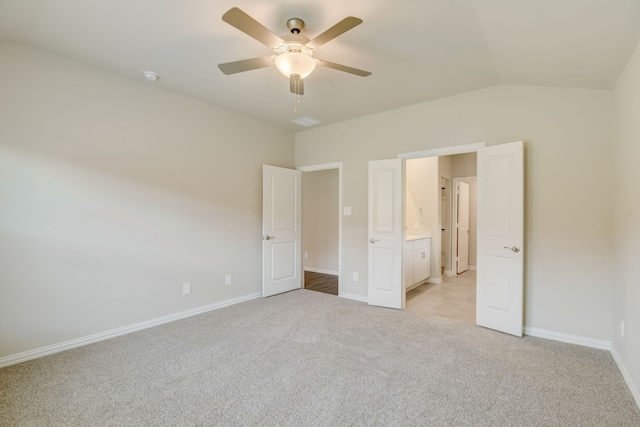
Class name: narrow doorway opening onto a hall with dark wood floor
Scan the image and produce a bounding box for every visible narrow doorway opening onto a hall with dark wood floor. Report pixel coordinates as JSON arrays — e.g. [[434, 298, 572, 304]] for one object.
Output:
[[299, 163, 342, 295]]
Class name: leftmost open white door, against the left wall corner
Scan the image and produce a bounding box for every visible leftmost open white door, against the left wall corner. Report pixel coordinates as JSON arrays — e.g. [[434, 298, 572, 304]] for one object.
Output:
[[262, 165, 302, 297]]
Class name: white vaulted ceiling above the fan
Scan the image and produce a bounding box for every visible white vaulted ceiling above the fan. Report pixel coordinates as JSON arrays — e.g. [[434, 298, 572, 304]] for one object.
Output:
[[0, 0, 640, 131]]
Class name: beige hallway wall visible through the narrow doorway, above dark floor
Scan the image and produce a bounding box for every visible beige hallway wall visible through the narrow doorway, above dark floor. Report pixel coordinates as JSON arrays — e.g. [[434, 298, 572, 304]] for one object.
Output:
[[302, 169, 340, 274]]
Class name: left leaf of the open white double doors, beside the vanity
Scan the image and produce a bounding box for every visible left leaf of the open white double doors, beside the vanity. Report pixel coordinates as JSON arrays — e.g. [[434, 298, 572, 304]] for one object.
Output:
[[367, 159, 405, 308]]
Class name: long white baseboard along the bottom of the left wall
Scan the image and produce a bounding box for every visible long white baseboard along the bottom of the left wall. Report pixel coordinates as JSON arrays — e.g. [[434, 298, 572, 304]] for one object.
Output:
[[0, 292, 262, 368]]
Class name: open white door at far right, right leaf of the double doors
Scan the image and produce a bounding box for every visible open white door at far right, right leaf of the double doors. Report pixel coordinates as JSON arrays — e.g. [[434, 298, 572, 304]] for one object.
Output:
[[476, 141, 524, 337]]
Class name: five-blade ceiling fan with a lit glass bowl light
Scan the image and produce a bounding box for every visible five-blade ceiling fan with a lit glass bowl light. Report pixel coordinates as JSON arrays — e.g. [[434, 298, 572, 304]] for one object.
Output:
[[218, 7, 371, 95]]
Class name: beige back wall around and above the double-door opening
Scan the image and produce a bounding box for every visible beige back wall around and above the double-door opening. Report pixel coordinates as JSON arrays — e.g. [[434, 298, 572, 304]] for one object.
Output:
[[296, 86, 613, 339]]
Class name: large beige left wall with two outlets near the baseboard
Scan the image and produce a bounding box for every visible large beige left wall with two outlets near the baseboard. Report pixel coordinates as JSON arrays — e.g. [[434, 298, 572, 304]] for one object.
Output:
[[0, 44, 294, 357]]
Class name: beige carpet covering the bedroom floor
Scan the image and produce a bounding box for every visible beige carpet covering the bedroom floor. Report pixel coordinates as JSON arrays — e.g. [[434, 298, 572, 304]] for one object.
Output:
[[0, 290, 640, 426]]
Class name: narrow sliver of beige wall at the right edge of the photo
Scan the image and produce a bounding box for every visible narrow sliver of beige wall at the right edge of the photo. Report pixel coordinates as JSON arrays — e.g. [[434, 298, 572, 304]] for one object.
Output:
[[612, 40, 640, 404]]
